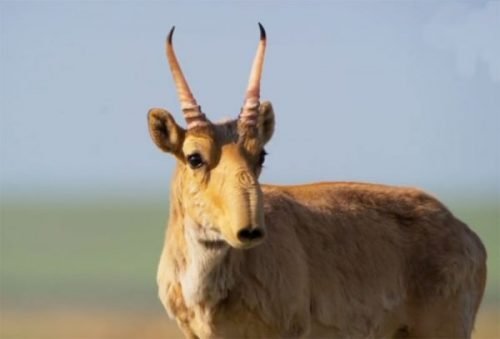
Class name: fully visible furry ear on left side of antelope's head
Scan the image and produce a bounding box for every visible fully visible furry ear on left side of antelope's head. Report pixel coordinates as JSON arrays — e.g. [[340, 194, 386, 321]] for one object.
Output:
[[148, 108, 186, 155]]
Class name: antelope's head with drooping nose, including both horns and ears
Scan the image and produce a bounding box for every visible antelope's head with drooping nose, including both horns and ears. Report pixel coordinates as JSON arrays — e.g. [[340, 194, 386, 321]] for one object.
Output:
[[148, 23, 274, 248]]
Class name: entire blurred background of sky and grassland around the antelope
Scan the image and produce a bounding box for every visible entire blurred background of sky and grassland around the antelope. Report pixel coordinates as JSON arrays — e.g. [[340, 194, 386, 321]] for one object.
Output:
[[0, 1, 500, 338]]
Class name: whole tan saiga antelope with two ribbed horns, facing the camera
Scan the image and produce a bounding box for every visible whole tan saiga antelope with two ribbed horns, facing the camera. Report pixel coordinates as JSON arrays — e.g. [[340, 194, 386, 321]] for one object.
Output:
[[148, 24, 486, 338]]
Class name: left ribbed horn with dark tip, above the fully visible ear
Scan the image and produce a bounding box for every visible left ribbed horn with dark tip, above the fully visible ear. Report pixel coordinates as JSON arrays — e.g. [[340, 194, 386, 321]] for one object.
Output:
[[166, 26, 208, 129]]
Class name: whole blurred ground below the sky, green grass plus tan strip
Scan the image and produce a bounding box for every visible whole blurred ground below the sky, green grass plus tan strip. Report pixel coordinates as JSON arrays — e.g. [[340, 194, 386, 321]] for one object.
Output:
[[0, 200, 500, 338]]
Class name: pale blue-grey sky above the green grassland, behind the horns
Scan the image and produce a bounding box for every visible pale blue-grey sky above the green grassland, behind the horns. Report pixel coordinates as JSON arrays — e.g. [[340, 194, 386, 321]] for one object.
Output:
[[0, 1, 500, 198]]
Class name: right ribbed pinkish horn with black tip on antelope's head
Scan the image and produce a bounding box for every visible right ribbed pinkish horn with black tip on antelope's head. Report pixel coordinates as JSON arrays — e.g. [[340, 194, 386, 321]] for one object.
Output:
[[239, 22, 266, 125]]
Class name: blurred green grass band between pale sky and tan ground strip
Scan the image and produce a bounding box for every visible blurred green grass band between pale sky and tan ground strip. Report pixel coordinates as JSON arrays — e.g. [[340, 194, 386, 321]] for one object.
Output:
[[0, 200, 500, 312]]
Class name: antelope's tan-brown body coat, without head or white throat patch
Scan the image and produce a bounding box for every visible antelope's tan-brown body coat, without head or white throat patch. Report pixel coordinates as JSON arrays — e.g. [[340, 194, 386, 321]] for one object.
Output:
[[158, 183, 486, 338]]
